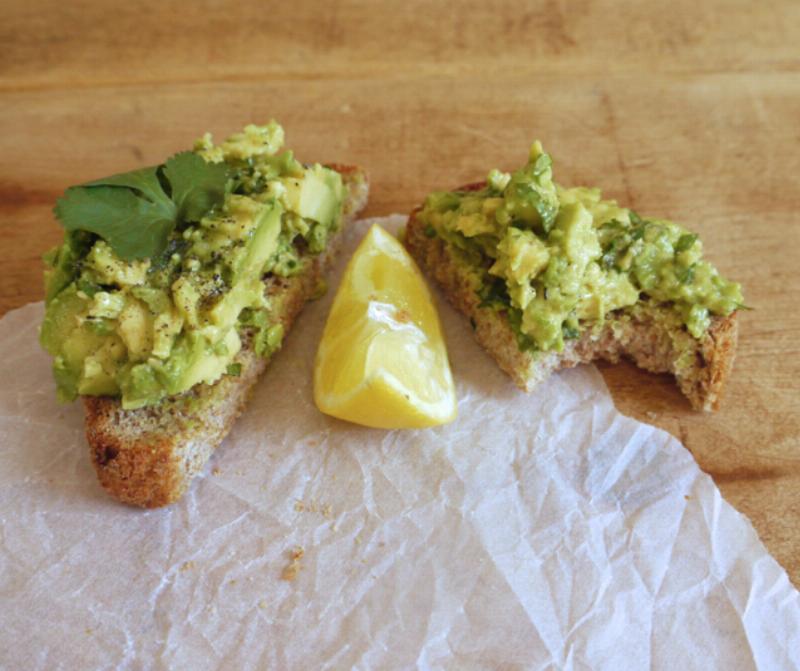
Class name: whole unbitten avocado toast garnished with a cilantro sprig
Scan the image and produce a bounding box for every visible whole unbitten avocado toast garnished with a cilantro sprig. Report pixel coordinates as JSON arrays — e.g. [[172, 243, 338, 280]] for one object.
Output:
[[41, 122, 368, 507]]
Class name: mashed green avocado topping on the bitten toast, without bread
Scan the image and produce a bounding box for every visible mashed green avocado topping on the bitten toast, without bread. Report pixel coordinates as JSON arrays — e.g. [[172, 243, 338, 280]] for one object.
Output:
[[418, 142, 742, 351]]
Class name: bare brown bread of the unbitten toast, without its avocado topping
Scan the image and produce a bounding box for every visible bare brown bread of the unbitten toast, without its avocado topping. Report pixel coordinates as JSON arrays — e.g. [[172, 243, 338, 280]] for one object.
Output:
[[83, 165, 369, 508]]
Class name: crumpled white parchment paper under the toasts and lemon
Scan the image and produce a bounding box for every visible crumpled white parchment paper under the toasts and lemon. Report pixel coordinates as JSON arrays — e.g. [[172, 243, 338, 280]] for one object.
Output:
[[0, 217, 800, 670]]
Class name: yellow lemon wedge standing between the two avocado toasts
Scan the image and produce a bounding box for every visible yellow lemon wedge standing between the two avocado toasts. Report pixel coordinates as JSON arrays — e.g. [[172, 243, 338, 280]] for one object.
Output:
[[314, 224, 456, 429]]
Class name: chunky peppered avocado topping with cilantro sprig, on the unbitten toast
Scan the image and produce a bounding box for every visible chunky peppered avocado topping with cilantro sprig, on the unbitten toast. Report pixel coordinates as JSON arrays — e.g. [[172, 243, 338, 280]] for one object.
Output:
[[40, 121, 345, 408]]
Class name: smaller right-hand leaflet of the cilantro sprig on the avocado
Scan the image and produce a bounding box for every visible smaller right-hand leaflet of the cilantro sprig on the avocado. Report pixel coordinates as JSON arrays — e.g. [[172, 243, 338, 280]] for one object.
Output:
[[164, 151, 228, 221]]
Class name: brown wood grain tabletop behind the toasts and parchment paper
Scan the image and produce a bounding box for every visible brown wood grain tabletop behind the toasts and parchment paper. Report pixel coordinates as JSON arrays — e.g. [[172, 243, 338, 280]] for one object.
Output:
[[0, 0, 800, 585]]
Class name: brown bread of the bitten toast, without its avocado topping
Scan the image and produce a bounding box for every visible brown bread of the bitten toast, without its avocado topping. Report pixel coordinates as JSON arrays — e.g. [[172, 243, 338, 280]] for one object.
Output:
[[405, 183, 738, 411]]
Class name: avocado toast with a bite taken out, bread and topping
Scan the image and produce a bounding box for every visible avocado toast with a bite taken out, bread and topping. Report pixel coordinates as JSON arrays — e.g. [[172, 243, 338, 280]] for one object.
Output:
[[405, 142, 743, 410]]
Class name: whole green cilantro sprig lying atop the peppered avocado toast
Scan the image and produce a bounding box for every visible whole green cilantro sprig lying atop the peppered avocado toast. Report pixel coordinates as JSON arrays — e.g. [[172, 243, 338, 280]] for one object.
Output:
[[54, 151, 229, 261]]
